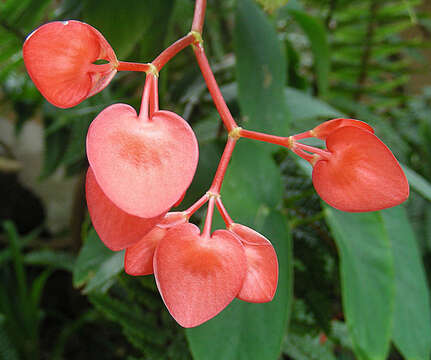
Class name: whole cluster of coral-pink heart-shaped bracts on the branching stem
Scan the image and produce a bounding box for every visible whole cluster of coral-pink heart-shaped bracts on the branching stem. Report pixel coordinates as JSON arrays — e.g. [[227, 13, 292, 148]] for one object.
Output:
[[23, 21, 409, 327]]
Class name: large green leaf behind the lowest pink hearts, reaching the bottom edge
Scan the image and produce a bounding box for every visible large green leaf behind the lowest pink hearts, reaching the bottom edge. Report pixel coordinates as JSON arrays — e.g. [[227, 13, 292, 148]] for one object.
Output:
[[187, 140, 292, 360]]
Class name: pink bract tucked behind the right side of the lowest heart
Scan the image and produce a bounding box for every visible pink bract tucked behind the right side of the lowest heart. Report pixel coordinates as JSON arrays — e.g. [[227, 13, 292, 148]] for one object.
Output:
[[229, 223, 278, 303]]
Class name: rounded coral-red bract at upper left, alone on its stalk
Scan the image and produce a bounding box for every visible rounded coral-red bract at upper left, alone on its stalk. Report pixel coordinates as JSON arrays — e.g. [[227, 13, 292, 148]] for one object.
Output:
[[23, 20, 118, 108]]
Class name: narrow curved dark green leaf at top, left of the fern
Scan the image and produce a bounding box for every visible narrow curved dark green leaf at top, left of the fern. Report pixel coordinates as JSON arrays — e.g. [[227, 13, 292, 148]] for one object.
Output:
[[289, 10, 330, 96]]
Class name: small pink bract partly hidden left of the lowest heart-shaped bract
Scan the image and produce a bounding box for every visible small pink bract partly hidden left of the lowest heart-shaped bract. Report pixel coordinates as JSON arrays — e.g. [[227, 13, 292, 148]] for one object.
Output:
[[124, 212, 187, 276]]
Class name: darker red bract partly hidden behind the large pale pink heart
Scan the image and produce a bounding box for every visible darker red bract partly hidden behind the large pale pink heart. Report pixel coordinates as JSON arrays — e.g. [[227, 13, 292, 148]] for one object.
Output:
[[85, 168, 164, 251]]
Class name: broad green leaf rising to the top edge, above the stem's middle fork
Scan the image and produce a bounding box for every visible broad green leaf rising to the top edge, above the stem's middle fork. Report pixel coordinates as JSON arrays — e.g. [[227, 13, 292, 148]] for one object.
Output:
[[234, 0, 289, 135]]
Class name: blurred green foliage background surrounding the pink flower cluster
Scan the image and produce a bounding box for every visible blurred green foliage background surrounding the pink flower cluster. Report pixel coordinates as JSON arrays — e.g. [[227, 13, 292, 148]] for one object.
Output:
[[0, 0, 431, 360]]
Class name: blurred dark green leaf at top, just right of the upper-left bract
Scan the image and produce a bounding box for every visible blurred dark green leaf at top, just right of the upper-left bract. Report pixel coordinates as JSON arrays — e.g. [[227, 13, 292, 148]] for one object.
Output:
[[83, 0, 174, 62]]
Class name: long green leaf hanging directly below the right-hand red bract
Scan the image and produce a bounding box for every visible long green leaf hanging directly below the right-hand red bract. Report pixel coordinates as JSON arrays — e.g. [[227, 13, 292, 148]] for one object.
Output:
[[325, 206, 395, 360]]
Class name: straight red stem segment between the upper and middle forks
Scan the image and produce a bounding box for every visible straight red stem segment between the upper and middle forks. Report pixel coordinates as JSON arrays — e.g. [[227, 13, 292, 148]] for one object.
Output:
[[193, 44, 237, 132]]
